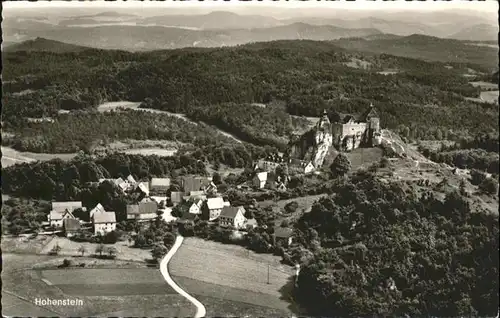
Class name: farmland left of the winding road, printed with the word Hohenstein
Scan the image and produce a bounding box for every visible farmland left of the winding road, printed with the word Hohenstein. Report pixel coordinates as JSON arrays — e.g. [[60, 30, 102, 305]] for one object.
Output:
[[2, 253, 195, 317]]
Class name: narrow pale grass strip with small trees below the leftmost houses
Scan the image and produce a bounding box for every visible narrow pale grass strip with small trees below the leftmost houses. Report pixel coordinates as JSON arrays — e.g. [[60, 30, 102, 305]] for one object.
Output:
[[40, 237, 151, 262]]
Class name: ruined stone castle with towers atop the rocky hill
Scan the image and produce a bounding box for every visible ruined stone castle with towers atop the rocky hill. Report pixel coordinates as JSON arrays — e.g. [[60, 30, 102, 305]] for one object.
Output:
[[322, 104, 380, 151]]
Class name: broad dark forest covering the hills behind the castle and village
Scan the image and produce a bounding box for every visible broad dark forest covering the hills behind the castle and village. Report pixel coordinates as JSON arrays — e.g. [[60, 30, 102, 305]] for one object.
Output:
[[3, 41, 498, 151]]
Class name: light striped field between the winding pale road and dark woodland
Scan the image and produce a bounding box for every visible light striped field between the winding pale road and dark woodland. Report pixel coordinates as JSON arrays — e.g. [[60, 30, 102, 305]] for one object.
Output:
[[169, 238, 293, 315]]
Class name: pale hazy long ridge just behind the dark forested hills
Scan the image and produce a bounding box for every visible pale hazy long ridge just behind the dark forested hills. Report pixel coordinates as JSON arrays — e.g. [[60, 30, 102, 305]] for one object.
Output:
[[2, 23, 380, 51]]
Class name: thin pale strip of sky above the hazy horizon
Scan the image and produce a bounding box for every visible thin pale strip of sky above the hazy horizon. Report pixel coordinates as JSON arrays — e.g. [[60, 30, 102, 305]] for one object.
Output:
[[3, 0, 498, 12]]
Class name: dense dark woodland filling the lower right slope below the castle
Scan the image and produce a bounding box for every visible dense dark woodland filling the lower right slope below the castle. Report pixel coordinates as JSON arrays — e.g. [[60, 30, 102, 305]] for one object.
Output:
[[292, 176, 499, 317]]
